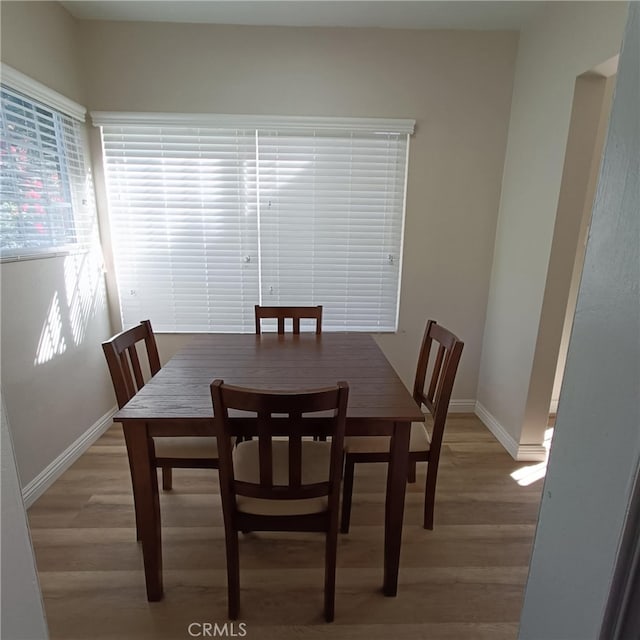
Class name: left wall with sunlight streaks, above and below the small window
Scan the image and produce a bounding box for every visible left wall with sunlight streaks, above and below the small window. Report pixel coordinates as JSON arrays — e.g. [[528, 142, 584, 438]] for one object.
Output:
[[0, 2, 115, 487]]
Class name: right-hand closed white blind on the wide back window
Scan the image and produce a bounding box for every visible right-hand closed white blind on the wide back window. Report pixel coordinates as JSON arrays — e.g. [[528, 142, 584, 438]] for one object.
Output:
[[258, 132, 407, 331]]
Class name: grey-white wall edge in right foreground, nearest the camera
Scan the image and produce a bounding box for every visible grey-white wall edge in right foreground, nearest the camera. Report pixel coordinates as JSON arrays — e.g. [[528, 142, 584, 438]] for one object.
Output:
[[520, 3, 640, 640]]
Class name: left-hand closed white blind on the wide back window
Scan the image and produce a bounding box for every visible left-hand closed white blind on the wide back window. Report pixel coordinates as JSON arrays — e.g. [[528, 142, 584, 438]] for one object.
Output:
[[102, 126, 258, 332]]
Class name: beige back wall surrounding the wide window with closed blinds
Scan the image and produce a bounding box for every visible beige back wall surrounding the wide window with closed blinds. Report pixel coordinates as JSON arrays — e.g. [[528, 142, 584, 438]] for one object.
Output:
[[80, 22, 517, 410]]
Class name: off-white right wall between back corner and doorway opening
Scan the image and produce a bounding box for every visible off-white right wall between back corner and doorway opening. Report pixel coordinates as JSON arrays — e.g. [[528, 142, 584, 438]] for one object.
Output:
[[477, 2, 626, 457]]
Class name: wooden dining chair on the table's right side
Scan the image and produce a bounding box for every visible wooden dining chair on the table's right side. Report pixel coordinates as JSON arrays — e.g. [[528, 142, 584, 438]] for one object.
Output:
[[340, 320, 464, 533]]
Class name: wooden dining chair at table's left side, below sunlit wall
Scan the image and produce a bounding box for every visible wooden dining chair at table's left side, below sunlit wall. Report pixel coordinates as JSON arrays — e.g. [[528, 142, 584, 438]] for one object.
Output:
[[102, 320, 218, 532]]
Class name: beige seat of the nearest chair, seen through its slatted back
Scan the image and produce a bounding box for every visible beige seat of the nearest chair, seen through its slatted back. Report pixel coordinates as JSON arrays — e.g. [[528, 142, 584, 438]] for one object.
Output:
[[233, 440, 331, 516]]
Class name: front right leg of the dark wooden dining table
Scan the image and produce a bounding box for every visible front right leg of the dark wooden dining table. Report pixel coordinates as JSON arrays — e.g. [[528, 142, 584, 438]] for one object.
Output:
[[382, 422, 411, 596]]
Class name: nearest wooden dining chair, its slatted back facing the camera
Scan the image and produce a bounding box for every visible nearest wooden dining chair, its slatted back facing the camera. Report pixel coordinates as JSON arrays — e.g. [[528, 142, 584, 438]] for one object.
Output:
[[211, 380, 349, 622]]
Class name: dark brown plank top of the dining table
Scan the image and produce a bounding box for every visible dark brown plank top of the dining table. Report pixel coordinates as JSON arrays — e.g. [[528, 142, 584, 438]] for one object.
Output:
[[114, 333, 424, 431]]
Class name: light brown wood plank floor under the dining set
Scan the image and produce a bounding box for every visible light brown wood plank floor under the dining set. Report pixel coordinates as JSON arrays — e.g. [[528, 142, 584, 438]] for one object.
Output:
[[28, 414, 542, 640]]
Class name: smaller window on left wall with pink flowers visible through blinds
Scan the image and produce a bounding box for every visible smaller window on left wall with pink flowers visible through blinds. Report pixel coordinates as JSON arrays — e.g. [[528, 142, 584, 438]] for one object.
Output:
[[0, 65, 93, 259]]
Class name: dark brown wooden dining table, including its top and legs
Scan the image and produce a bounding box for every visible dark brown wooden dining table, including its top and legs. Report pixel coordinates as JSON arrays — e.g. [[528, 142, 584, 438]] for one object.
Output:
[[114, 333, 424, 601]]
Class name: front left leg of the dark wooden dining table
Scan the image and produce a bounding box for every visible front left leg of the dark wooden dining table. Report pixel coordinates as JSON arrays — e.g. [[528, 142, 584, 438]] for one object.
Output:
[[123, 421, 162, 602]]
